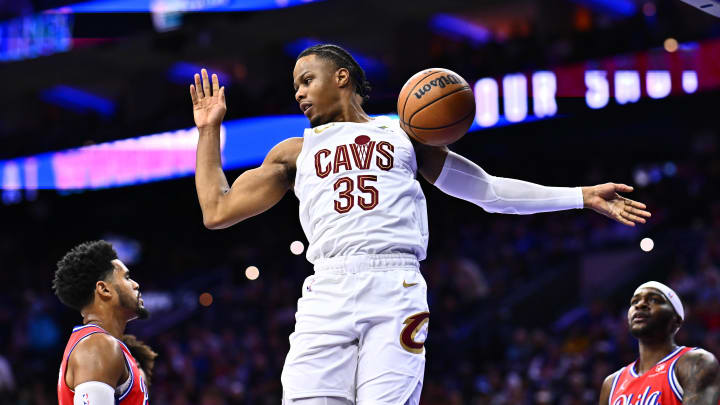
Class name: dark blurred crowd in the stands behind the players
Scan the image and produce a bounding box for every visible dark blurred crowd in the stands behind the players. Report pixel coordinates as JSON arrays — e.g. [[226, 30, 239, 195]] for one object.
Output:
[[0, 122, 720, 405]]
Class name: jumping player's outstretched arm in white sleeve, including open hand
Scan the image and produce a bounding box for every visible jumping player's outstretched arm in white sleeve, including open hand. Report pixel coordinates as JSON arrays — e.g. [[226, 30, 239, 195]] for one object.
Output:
[[415, 143, 650, 226]]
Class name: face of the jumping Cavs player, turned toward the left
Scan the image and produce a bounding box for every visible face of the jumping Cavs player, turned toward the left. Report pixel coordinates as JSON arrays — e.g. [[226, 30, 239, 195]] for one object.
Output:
[[293, 55, 342, 127]]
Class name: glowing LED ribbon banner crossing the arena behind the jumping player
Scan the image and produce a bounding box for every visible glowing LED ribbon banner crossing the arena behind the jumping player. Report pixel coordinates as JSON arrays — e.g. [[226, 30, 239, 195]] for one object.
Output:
[[0, 40, 720, 197]]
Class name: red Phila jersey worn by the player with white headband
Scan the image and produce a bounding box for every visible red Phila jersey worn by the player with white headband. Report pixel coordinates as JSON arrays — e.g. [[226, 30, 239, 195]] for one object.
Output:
[[608, 347, 694, 405]]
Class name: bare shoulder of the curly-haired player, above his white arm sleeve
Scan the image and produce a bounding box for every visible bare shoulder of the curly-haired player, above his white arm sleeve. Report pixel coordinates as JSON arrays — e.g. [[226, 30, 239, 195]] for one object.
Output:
[[66, 333, 126, 387]]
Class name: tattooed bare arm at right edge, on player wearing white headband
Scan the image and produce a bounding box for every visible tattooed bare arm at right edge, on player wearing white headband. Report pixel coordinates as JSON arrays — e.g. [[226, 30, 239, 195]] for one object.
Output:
[[675, 349, 720, 405]]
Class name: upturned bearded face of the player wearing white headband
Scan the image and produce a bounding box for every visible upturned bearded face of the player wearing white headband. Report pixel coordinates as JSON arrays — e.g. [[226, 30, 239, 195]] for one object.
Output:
[[628, 288, 678, 339]]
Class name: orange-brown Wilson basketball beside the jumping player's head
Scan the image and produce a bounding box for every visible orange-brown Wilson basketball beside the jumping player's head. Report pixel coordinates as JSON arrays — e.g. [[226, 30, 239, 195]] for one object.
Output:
[[397, 68, 475, 146]]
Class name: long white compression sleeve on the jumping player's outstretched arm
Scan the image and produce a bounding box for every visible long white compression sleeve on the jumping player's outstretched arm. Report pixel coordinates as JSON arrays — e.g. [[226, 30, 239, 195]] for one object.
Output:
[[435, 152, 583, 214]]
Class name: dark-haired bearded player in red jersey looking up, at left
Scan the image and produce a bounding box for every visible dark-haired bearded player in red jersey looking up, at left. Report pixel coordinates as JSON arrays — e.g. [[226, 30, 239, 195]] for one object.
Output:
[[53, 241, 148, 405]]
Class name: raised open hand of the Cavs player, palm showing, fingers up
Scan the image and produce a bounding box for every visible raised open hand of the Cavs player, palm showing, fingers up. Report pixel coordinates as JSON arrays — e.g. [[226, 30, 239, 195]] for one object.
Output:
[[190, 69, 227, 128]]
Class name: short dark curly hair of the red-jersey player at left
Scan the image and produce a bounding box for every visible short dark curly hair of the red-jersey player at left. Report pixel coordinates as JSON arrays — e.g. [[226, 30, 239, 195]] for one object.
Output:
[[52, 240, 118, 311]]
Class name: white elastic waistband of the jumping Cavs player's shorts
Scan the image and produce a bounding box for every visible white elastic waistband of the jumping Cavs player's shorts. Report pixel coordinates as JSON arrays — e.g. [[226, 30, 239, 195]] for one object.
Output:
[[315, 253, 420, 274]]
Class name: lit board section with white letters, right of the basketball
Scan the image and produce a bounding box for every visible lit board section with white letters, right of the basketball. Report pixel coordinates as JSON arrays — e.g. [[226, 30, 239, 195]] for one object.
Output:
[[473, 40, 720, 128]]
